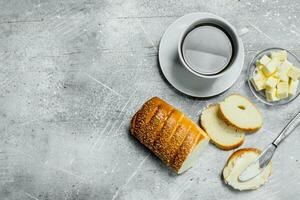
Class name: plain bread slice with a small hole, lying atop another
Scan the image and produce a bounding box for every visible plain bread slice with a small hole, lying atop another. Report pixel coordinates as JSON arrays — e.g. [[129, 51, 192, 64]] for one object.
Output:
[[220, 94, 263, 132]]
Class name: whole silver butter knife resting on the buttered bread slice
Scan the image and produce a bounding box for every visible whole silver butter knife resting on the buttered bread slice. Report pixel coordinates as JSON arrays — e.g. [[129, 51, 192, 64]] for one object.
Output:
[[239, 111, 300, 182]]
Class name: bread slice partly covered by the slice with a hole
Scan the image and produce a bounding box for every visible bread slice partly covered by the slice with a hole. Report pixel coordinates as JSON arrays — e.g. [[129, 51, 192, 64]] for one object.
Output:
[[200, 104, 245, 150]]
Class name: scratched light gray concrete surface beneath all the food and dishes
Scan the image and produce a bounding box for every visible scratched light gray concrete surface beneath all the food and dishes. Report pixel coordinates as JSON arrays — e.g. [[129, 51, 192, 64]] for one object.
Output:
[[0, 0, 300, 200]]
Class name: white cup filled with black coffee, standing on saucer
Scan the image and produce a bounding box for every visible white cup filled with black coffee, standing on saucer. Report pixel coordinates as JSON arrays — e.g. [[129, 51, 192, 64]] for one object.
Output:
[[178, 14, 242, 79]]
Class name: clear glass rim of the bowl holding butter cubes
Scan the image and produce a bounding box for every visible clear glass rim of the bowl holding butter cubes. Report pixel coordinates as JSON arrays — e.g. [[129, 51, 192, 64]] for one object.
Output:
[[247, 47, 300, 106]]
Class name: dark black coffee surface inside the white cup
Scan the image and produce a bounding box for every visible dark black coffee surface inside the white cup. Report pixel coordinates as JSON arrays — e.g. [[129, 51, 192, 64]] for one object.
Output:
[[182, 24, 233, 75]]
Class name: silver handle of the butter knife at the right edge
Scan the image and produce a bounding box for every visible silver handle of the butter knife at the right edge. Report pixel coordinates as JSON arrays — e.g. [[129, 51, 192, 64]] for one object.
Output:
[[272, 111, 300, 147]]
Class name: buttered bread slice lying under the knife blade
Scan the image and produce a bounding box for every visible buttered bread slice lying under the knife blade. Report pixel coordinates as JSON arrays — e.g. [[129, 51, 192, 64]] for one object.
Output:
[[223, 148, 272, 190]]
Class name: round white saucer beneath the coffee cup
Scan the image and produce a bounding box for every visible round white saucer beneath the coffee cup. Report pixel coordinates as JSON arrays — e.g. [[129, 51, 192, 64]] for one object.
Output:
[[158, 13, 244, 97]]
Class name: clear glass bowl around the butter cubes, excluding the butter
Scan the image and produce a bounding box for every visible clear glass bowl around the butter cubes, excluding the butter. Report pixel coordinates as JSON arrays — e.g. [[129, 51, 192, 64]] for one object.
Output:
[[247, 47, 300, 105]]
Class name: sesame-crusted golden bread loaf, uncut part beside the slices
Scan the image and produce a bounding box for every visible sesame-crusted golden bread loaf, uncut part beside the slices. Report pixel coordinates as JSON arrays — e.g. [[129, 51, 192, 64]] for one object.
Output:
[[131, 97, 208, 174]]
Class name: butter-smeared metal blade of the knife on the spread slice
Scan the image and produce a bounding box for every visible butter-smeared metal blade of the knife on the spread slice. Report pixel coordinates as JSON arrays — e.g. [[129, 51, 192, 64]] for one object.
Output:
[[239, 143, 277, 182]]
